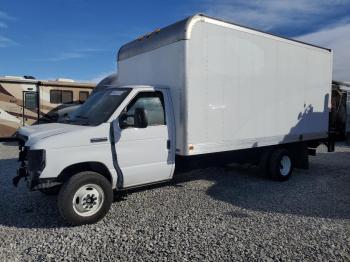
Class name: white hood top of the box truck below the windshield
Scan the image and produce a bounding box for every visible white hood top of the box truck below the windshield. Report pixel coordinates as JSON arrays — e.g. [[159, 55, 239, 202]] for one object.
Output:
[[18, 123, 85, 141]]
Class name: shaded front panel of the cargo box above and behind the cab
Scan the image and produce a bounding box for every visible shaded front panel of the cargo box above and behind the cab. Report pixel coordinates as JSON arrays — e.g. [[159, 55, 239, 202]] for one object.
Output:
[[118, 40, 187, 154]]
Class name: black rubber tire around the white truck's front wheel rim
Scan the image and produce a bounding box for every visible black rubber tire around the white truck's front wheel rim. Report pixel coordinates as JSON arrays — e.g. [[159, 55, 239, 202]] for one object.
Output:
[[57, 171, 113, 226]]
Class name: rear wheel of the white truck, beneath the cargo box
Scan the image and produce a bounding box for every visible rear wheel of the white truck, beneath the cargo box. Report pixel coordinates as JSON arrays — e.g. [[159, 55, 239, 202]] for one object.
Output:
[[269, 148, 294, 181]]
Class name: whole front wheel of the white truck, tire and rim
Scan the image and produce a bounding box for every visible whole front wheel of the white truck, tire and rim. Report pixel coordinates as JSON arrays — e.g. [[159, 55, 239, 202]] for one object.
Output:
[[58, 171, 113, 225]]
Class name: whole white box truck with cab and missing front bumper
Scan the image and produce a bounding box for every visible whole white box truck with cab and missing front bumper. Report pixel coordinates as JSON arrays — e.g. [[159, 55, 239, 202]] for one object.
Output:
[[14, 15, 334, 225]]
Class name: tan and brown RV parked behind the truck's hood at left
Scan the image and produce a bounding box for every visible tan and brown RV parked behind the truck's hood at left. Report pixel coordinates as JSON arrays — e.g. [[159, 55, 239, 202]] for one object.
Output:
[[0, 77, 95, 140]]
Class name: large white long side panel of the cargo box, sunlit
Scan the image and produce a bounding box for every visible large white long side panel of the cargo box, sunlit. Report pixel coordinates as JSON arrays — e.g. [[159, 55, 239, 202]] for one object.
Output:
[[186, 22, 332, 154]]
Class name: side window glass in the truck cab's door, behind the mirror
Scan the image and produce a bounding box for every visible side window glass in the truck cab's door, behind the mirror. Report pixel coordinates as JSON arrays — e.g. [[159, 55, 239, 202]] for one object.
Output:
[[127, 91, 165, 126]]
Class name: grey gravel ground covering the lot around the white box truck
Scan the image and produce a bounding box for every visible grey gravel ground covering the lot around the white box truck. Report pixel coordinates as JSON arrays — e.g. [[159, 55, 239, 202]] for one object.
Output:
[[0, 144, 350, 261]]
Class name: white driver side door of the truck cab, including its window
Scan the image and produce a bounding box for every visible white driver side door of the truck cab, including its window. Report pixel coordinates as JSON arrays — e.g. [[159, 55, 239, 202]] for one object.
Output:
[[116, 91, 174, 187]]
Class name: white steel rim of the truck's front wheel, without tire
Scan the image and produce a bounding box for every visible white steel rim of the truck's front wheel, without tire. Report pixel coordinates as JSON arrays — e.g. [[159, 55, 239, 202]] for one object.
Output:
[[72, 184, 104, 217]]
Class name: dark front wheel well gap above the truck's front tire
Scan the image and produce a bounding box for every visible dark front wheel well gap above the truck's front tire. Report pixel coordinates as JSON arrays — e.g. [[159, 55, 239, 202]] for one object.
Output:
[[57, 162, 112, 183]]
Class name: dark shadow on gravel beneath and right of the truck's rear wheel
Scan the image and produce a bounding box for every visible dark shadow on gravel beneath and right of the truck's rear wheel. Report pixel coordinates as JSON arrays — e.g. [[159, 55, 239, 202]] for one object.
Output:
[[174, 152, 350, 219]]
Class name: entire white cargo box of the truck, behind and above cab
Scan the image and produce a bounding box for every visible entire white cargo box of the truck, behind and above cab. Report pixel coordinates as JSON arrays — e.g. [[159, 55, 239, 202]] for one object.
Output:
[[118, 15, 332, 155]]
